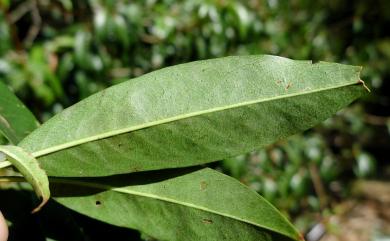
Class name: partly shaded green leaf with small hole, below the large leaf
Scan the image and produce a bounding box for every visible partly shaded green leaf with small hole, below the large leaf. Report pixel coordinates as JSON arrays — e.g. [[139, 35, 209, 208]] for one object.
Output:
[[50, 168, 300, 241]]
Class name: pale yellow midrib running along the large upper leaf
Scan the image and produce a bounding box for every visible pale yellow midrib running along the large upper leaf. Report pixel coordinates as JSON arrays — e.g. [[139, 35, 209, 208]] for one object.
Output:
[[31, 82, 360, 158]]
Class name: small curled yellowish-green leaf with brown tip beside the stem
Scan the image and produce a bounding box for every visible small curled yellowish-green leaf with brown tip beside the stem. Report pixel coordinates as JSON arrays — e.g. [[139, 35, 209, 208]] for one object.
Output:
[[0, 145, 50, 213]]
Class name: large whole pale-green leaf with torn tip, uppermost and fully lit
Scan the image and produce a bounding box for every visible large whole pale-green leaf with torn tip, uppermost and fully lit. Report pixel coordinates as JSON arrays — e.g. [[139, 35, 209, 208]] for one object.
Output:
[[20, 55, 365, 176]]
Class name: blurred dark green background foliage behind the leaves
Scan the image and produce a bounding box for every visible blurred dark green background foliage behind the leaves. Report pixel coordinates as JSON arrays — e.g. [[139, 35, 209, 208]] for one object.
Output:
[[0, 0, 390, 240]]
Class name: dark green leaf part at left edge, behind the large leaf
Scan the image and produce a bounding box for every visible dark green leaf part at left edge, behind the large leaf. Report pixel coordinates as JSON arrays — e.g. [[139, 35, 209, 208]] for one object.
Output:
[[0, 82, 39, 145]]
